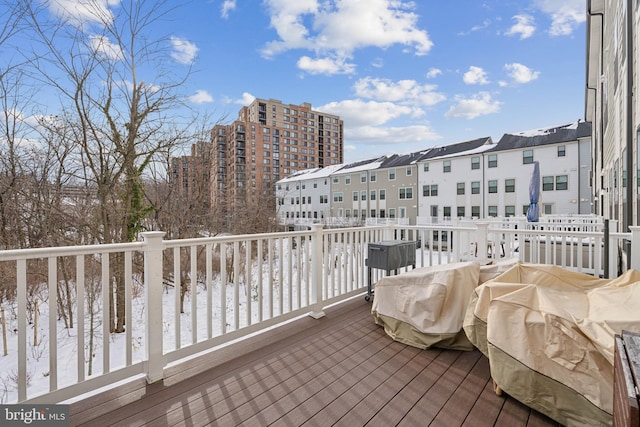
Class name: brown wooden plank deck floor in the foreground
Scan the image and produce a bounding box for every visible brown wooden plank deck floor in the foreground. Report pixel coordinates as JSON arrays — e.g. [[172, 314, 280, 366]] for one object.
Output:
[[71, 298, 558, 427]]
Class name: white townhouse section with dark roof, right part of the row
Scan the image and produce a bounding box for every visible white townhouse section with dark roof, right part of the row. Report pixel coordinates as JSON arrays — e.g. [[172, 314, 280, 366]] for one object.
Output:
[[418, 121, 592, 223]]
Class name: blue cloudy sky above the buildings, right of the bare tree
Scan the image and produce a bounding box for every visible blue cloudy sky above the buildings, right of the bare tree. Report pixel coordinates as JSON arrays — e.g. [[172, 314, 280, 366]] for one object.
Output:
[[13, 0, 586, 161]]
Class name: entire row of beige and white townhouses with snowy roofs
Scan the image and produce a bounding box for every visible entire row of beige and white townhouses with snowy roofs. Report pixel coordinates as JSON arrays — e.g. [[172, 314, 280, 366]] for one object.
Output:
[[276, 121, 593, 225]]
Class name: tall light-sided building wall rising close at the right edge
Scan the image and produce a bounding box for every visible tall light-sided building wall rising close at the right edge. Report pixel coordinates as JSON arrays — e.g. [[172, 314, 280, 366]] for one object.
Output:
[[585, 0, 640, 232]]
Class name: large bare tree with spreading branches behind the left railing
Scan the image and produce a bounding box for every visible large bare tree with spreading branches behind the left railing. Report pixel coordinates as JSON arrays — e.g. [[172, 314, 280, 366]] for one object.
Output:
[[23, 0, 200, 332]]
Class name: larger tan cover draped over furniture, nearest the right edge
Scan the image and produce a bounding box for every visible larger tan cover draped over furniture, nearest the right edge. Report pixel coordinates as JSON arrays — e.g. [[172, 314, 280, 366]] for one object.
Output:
[[464, 264, 640, 426]]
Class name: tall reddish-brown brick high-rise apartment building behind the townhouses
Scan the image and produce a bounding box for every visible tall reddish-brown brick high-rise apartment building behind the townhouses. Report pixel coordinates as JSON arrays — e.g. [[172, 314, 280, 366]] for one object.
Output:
[[211, 99, 344, 214]]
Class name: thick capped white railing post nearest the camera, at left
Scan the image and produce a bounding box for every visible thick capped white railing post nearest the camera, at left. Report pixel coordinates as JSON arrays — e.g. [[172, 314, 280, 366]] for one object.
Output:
[[142, 231, 165, 383]]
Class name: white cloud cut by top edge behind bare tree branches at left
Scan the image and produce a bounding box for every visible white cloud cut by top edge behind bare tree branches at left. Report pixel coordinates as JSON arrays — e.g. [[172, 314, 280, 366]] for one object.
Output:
[[47, 0, 120, 27]]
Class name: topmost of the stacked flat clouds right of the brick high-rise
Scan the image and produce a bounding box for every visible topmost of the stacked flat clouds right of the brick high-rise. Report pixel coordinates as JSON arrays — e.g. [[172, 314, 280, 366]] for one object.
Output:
[[353, 77, 446, 106]]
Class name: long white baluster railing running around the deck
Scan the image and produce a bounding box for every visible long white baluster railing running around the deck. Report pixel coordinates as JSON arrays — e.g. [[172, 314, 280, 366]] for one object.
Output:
[[0, 222, 640, 403]]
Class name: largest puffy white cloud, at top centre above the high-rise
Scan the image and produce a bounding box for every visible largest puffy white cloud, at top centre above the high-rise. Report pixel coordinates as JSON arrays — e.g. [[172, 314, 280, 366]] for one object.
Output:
[[262, 0, 433, 72]]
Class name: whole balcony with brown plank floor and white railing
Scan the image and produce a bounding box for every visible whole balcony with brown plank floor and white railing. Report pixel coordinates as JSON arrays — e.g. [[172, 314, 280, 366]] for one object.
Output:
[[0, 222, 640, 426]]
